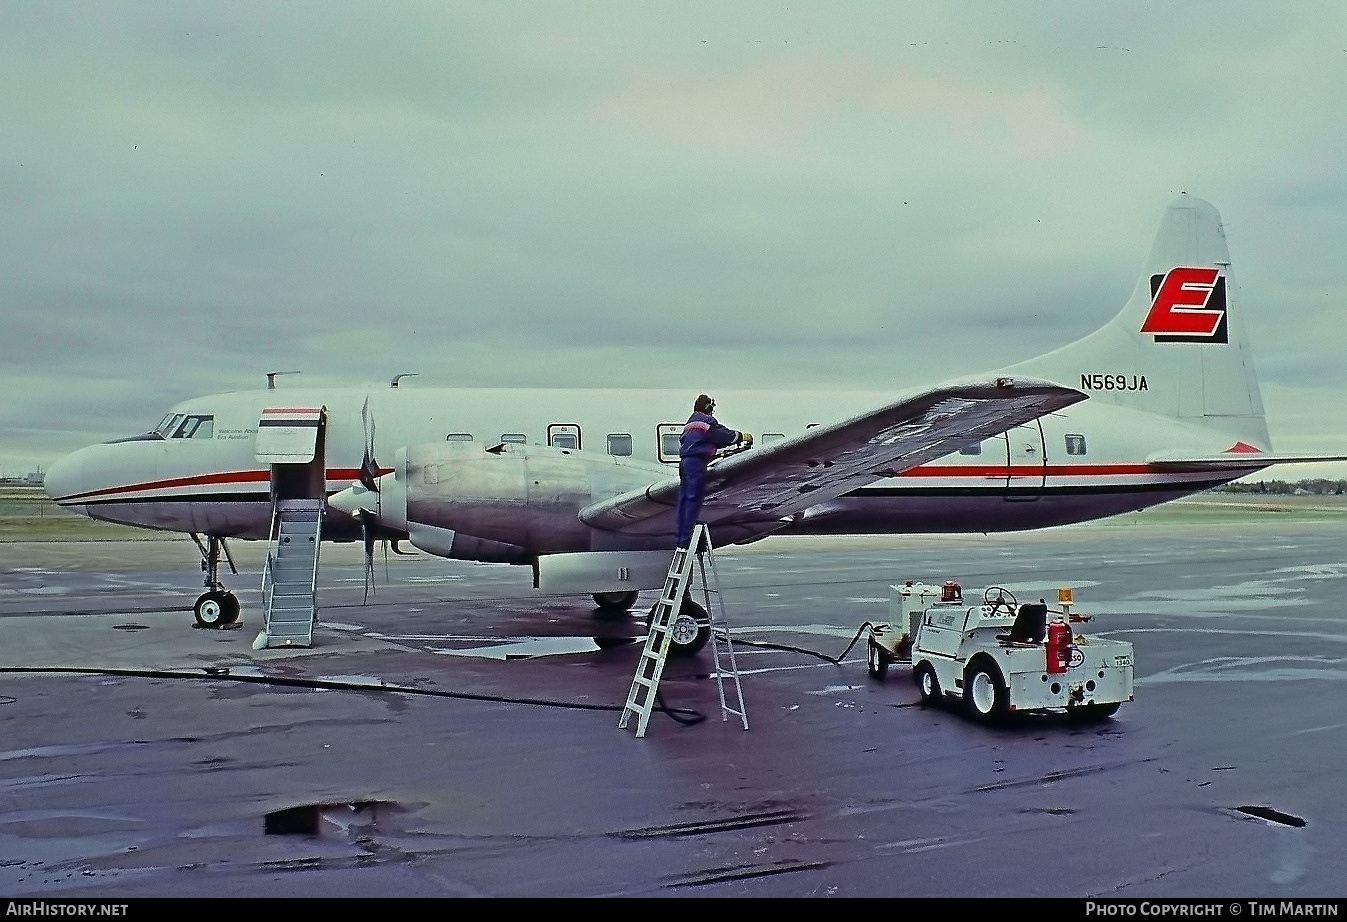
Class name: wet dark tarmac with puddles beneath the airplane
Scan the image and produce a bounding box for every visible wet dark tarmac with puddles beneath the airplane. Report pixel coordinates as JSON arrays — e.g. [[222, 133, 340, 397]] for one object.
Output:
[[0, 520, 1347, 898]]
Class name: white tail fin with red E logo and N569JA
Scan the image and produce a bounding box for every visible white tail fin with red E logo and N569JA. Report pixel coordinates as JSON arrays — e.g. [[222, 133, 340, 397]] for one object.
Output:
[[1008, 194, 1272, 452]]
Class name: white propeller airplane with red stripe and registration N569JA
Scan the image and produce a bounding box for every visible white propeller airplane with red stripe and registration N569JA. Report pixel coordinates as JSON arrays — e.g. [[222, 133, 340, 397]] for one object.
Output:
[[46, 195, 1347, 650]]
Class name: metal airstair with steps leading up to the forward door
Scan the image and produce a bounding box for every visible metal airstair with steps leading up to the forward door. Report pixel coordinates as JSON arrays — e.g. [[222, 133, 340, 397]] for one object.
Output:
[[253, 499, 323, 650]]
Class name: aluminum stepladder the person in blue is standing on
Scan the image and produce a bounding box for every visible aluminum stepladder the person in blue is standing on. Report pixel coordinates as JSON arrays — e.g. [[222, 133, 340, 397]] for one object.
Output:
[[617, 523, 749, 737]]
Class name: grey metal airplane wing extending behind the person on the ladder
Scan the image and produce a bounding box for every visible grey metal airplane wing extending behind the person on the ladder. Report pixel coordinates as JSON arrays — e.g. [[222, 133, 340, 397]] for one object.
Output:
[[579, 377, 1086, 545]]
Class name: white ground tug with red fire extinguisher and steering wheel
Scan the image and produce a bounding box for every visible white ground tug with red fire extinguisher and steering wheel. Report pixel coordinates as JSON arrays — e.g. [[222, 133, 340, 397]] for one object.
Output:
[[867, 582, 1133, 723]]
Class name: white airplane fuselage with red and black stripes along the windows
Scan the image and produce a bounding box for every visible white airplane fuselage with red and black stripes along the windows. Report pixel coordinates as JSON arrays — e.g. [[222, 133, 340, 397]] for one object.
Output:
[[47, 387, 1247, 554]]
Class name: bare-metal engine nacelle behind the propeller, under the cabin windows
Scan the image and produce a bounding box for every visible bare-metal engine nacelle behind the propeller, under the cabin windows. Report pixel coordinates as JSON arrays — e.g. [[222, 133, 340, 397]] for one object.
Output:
[[380, 442, 671, 557]]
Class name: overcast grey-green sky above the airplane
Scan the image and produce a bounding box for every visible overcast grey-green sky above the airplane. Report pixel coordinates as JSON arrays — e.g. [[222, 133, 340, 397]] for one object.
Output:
[[0, 0, 1347, 480]]
